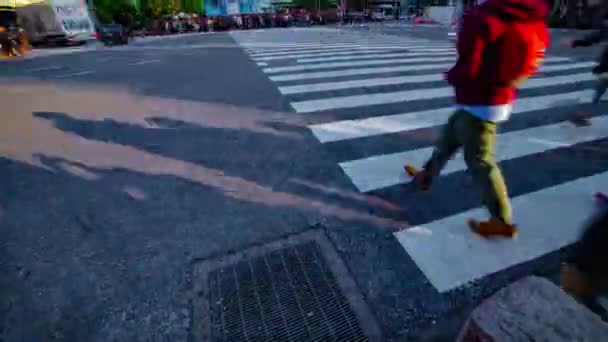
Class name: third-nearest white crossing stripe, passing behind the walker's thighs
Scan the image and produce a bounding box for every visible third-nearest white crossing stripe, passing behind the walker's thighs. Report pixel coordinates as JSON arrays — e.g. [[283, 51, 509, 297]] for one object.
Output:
[[309, 90, 591, 143]]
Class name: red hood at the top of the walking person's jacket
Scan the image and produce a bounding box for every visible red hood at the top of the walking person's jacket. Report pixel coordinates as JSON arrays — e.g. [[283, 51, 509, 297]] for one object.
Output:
[[479, 0, 549, 22]]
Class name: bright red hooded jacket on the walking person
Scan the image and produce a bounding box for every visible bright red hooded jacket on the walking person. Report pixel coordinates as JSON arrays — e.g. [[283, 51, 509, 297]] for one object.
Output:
[[447, 0, 550, 106]]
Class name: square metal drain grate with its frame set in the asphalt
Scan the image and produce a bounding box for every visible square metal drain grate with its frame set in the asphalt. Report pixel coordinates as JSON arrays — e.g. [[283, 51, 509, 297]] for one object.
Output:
[[194, 231, 380, 342]]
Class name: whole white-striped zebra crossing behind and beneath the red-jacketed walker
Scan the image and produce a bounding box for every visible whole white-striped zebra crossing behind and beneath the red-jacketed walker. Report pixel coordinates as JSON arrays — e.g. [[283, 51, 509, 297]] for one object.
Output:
[[233, 29, 608, 293]]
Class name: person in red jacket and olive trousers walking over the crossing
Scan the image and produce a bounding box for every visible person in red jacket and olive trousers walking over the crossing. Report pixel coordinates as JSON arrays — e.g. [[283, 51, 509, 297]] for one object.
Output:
[[405, 0, 550, 237]]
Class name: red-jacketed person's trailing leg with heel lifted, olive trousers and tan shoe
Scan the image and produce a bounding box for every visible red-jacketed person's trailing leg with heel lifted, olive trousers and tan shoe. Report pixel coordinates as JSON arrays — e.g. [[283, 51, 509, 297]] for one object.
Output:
[[405, 110, 469, 190]]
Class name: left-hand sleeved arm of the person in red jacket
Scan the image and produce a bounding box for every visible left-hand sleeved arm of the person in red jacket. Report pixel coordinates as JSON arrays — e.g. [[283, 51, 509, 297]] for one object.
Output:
[[446, 15, 485, 85]]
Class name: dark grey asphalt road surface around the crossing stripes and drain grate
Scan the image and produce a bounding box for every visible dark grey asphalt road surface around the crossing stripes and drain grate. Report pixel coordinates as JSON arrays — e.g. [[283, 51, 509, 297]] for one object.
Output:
[[0, 28, 607, 341]]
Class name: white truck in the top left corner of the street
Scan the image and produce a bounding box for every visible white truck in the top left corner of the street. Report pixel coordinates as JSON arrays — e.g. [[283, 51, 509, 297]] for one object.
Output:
[[13, 0, 97, 45]]
